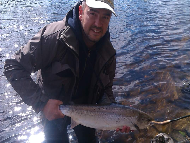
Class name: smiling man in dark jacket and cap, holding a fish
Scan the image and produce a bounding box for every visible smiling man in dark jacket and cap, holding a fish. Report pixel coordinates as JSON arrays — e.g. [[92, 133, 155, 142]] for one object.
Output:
[[4, 0, 131, 143]]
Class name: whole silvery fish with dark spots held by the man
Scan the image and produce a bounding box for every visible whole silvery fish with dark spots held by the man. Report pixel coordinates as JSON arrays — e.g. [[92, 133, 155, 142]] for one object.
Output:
[[60, 104, 153, 130]]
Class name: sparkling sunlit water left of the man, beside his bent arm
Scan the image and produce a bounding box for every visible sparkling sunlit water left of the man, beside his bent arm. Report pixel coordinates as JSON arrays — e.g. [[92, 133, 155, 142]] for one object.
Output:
[[0, 0, 75, 143]]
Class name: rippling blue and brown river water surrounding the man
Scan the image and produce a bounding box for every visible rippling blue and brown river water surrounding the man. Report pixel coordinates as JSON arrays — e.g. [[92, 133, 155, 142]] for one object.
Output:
[[0, 0, 190, 143]]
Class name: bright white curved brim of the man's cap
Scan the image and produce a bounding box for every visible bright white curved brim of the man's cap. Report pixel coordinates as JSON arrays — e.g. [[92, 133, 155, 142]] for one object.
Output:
[[86, 0, 117, 16]]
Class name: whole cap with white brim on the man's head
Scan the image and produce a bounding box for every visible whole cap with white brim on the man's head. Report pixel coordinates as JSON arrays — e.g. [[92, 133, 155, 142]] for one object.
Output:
[[83, 0, 117, 16]]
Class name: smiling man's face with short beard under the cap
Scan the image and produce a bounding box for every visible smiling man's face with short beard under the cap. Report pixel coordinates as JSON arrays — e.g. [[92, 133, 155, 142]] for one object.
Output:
[[79, 5, 112, 43]]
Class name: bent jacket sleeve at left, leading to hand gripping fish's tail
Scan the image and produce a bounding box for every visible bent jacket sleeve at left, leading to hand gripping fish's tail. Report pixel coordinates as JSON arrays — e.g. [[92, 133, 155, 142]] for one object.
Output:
[[4, 27, 57, 112]]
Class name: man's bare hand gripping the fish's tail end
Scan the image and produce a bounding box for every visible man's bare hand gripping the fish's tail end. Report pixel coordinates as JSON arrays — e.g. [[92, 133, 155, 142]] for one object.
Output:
[[42, 99, 65, 121]]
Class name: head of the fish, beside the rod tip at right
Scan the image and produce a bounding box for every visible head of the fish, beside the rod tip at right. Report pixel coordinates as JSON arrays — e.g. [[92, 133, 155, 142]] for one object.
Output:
[[136, 112, 153, 129]]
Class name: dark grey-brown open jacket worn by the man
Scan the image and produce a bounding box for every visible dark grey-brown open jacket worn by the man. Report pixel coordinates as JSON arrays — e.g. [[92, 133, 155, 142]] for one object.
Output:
[[4, 5, 116, 112]]
